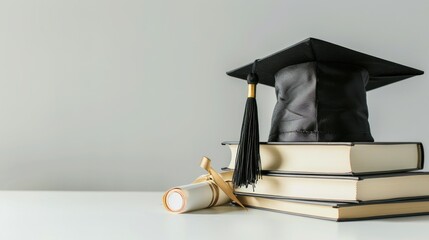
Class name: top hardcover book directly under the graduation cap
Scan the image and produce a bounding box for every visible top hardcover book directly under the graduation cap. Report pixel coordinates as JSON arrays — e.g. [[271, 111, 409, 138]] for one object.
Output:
[[222, 142, 424, 175]]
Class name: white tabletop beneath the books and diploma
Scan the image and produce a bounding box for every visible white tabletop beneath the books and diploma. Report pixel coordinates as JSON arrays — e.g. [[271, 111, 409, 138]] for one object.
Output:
[[0, 191, 429, 240]]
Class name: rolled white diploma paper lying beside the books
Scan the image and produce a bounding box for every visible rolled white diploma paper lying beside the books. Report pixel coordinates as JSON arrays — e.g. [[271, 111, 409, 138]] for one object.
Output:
[[162, 180, 230, 213]]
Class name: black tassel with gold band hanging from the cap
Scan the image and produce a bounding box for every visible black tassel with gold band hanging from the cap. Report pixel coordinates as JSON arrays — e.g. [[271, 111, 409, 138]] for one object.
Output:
[[232, 60, 262, 188]]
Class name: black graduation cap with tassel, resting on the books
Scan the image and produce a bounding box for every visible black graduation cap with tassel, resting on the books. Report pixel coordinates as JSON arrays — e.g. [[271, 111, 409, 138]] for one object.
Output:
[[227, 38, 423, 186]]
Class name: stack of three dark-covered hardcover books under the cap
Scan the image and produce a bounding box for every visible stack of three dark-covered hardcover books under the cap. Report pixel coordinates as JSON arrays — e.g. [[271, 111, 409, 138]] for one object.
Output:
[[223, 142, 429, 221]]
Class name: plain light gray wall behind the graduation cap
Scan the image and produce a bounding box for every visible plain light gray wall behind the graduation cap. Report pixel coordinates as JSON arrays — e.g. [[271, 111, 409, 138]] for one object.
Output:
[[0, 0, 429, 190]]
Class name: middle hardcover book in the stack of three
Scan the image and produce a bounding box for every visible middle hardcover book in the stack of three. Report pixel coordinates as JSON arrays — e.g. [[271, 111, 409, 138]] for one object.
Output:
[[235, 172, 429, 202]]
